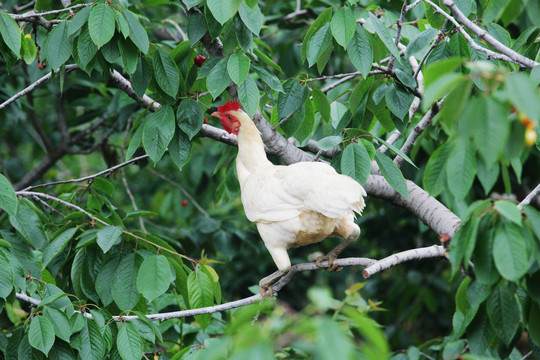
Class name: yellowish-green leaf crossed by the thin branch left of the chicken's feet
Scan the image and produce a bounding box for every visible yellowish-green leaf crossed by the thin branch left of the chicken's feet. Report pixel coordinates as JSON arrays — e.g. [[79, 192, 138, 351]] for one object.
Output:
[[188, 269, 214, 330]]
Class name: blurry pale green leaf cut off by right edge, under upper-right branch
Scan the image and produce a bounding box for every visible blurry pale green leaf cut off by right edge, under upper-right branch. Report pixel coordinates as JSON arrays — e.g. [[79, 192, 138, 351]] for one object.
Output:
[[506, 72, 540, 124]]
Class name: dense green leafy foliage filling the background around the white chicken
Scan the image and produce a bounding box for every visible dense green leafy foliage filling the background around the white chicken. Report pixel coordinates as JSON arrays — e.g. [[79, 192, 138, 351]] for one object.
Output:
[[0, 0, 540, 359]]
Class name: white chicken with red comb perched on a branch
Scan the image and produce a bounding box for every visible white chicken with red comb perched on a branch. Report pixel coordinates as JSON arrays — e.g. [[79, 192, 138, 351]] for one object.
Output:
[[212, 101, 366, 296]]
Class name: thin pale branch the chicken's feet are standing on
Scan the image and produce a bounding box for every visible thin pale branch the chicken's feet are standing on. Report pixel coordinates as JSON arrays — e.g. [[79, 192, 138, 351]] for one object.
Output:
[[16, 245, 445, 321]]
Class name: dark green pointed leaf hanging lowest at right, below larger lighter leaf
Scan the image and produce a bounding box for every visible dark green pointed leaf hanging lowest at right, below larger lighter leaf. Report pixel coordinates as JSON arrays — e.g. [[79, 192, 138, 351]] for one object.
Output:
[[487, 282, 520, 345]]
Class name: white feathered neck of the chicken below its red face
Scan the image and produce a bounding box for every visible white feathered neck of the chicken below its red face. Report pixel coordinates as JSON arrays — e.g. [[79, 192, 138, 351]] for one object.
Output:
[[236, 113, 273, 186]]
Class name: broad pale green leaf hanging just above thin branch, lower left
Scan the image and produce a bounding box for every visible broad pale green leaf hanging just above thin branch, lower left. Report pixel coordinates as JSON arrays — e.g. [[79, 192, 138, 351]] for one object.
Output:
[[137, 255, 172, 301]]
